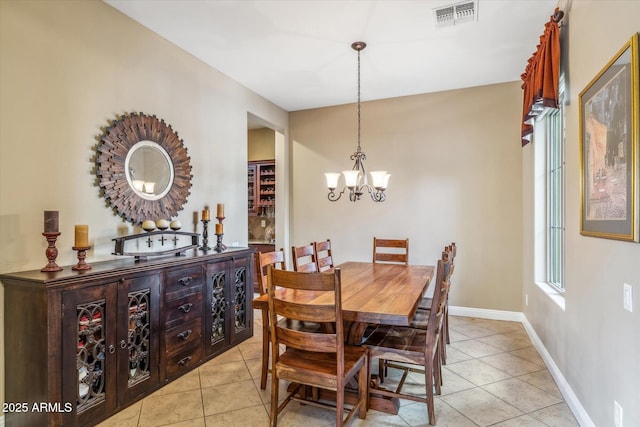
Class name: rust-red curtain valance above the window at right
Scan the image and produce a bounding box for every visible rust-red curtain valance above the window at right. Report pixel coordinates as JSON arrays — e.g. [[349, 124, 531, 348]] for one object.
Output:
[[521, 8, 563, 147]]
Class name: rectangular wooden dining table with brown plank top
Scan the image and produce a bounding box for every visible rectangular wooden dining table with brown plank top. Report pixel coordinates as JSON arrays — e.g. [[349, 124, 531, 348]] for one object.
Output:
[[253, 261, 435, 413]]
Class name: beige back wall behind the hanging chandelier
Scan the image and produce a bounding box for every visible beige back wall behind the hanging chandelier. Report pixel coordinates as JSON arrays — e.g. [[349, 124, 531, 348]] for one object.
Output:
[[289, 82, 522, 312]]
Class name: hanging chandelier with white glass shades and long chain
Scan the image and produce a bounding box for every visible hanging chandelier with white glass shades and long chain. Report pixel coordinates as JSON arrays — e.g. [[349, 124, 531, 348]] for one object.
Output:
[[324, 42, 390, 202]]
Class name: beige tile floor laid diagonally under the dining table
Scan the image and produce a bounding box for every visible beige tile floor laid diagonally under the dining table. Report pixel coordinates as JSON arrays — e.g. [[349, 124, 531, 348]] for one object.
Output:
[[99, 312, 578, 427]]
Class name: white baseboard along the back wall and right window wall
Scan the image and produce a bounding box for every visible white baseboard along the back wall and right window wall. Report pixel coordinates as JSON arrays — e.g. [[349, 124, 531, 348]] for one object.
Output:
[[449, 306, 595, 427]]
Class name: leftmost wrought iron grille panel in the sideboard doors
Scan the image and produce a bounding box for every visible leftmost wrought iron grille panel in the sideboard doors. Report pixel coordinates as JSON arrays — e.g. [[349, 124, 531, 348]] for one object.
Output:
[[76, 299, 106, 413]]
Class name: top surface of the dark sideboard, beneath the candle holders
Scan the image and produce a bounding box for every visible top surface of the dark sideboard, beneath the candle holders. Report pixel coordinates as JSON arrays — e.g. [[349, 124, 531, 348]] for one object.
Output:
[[0, 247, 254, 286]]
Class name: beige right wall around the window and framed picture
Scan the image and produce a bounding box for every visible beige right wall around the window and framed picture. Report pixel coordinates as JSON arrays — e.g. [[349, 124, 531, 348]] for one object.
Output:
[[522, 0, 640, 426]]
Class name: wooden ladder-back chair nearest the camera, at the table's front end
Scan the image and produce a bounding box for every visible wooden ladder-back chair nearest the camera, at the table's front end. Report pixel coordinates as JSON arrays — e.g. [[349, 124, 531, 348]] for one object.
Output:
[[267, 267, 369, 427]]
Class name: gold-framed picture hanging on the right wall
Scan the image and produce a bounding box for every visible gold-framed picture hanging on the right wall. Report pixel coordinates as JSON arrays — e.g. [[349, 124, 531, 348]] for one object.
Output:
[[579, 33, 640, 242]]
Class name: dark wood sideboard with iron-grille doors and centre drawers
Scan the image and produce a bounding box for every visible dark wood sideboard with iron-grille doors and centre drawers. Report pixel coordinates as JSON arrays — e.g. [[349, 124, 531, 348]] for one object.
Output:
[[0, 248, 254, 427]]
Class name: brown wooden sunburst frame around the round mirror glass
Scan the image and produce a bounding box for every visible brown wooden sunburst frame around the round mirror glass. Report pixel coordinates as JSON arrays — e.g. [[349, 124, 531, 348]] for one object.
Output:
[[96, 113, 193, 225]]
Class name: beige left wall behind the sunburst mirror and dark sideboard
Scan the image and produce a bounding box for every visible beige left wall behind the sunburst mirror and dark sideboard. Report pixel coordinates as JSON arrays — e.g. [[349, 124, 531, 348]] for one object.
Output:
[[0, 0, 288, 408]]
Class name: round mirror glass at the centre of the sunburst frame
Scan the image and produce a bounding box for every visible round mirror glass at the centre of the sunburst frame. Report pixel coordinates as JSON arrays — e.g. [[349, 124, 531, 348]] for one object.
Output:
[[124, 141, 173, 200]]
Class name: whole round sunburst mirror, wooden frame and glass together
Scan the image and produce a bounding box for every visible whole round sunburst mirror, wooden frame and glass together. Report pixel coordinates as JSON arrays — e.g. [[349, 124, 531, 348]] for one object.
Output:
[[96, 113, 192, 224]]
